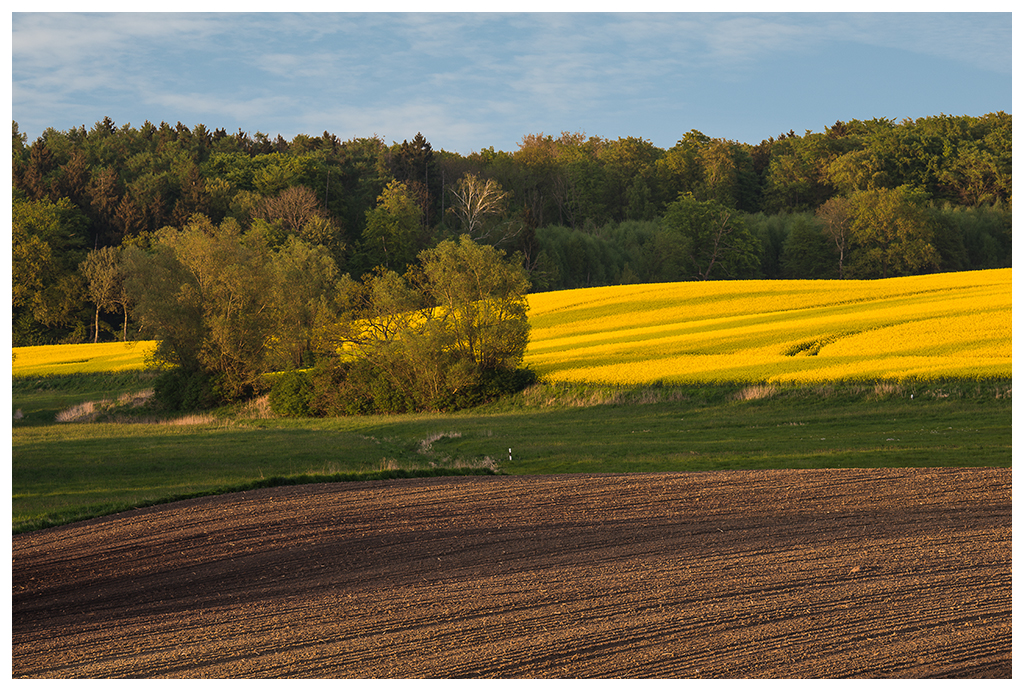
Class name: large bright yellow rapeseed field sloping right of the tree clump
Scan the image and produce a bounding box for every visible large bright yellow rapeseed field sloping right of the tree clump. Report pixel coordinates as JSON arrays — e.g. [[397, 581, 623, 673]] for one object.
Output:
[[525, 269, 1013, 385]]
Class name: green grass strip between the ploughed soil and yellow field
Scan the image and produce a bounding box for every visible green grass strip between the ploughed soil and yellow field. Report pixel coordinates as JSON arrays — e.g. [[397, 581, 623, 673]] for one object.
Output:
[[11, 378, 1012, 531]]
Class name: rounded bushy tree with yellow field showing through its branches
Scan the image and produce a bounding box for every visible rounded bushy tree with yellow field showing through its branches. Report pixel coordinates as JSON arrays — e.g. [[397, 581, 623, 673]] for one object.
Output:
[[313, 235, 529, 415]]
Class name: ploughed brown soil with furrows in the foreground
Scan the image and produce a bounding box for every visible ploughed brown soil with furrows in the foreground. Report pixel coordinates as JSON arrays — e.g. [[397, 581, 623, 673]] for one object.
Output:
[[12, 469, 1012, 678]]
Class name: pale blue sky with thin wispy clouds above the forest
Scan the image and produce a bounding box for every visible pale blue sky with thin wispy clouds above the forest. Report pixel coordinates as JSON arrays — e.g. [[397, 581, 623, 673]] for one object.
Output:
[[11, 7, 1012, 155]]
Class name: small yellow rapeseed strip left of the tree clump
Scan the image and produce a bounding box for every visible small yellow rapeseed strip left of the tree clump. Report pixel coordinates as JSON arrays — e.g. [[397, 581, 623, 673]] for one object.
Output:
[[11, 341, 157, 377]]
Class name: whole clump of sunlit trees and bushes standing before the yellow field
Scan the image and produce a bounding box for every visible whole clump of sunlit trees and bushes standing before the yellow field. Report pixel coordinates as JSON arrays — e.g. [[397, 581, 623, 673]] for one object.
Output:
[[100, 214, 529, 415]]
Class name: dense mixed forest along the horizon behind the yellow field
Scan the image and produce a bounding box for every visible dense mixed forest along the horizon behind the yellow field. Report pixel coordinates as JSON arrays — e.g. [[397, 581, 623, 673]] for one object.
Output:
[[12, 113, 1012, 352]]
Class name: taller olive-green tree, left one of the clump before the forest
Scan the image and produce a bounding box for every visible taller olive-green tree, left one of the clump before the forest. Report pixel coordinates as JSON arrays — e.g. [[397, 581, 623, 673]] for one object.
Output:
[[125, 215, 348, 400]]
